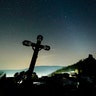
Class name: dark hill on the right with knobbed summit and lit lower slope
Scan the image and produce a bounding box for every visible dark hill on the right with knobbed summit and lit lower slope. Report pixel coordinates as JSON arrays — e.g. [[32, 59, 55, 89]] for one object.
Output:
[[50, 54, 96, 75]]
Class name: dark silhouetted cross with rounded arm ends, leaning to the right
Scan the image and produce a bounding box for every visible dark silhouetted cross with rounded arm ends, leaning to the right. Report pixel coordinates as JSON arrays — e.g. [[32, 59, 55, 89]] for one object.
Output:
[[22, 35, 50, 78]]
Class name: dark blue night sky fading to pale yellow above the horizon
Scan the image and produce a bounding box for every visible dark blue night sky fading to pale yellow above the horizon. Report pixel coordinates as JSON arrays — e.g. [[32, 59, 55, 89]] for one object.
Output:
[[0, 0, 96, 69]]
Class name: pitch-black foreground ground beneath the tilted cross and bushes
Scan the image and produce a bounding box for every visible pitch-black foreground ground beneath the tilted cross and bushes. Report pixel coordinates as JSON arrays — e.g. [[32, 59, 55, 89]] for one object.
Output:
[[0, 75, 96, 96]]
